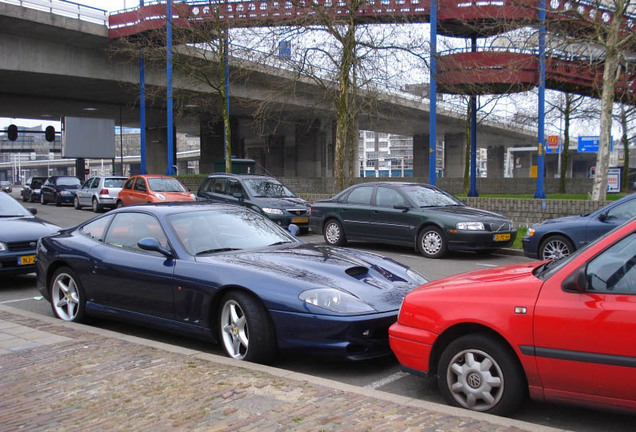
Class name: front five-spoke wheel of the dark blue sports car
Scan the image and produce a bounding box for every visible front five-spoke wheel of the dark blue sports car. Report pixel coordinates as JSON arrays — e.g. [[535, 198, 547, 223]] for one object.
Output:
[[218, 291, 278, 364]]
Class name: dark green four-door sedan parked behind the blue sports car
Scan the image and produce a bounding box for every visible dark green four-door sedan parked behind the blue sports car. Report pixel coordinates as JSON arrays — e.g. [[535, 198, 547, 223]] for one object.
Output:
[[309, 182, 517, 258]]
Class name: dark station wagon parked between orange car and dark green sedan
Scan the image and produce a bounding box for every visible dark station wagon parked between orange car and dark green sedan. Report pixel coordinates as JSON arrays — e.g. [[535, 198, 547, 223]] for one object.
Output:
[[197, 173, 310, 233]]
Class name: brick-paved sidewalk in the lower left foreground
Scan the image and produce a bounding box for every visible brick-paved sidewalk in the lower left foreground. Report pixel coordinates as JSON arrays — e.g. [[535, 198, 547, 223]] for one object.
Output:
[[0, 306, 568, 432]]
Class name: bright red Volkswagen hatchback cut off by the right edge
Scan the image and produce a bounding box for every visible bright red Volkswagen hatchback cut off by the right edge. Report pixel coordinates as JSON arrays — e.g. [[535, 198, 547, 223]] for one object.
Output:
[[389, 219, 636, 415]]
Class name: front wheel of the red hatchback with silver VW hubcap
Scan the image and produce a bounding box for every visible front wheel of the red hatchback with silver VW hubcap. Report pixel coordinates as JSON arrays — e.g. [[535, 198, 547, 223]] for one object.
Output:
[[437, 333, 528, 415]]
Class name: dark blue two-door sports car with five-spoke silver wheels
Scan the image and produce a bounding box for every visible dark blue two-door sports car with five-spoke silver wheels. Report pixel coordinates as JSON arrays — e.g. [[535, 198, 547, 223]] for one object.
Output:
[[36, 203, 426, 363]]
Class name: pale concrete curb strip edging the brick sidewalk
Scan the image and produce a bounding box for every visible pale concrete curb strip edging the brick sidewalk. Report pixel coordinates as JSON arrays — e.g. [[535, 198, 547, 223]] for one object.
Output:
[[0, 305, 564, 432]]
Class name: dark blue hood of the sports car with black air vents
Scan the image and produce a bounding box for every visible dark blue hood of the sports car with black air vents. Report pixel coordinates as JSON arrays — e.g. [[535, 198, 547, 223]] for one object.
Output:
[[197, 243, 419, 312]]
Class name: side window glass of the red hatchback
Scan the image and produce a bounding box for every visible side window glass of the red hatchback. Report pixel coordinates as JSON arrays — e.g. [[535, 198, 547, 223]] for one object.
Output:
[[587, 234, 636, 294]]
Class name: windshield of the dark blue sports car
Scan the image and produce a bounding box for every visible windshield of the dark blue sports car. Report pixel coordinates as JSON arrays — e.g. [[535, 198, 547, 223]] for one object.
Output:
[[169, 209, 299, 255]]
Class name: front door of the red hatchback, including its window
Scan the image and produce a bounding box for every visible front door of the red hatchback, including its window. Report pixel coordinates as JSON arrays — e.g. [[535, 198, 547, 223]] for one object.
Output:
[[534, 233, 636, 409]]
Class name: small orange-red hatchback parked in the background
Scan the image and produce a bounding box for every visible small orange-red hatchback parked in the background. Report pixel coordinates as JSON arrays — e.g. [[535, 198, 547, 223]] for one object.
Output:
[[117, 174, 195, 207]]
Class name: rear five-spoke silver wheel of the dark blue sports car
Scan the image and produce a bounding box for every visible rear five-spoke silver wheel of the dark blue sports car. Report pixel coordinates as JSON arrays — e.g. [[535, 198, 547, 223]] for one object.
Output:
[[49, 267, 86, 322]]
